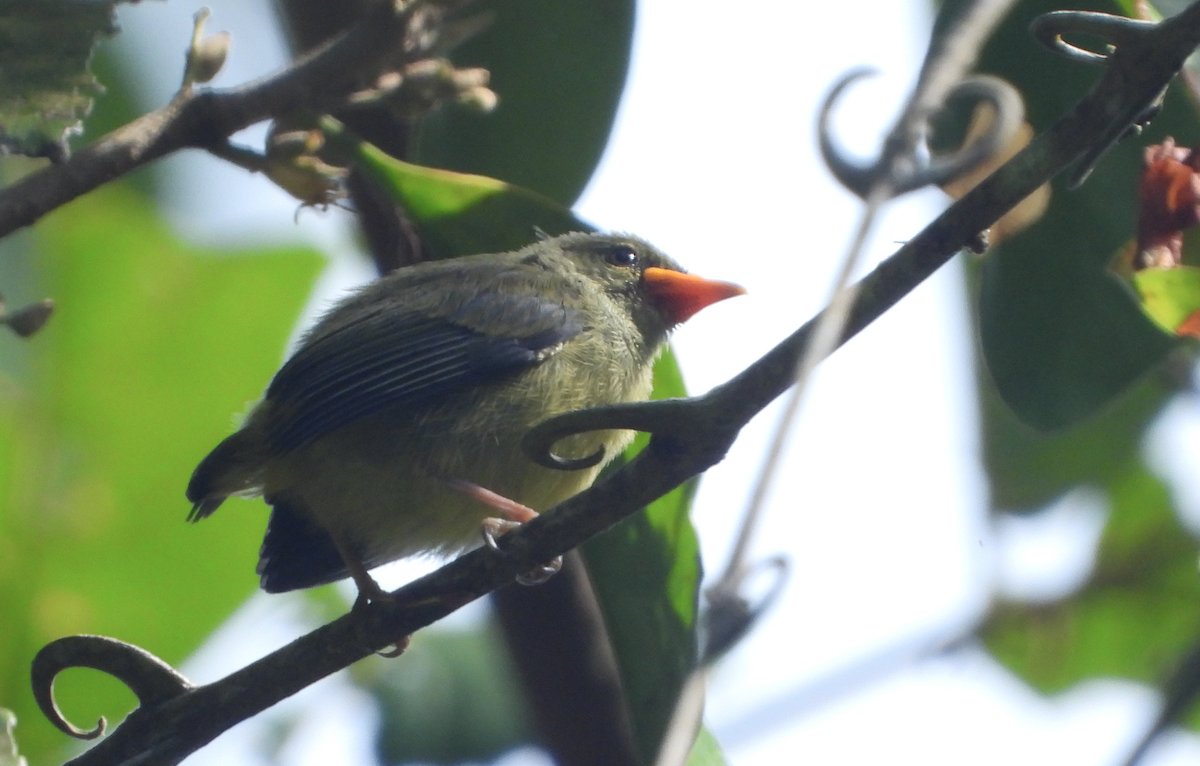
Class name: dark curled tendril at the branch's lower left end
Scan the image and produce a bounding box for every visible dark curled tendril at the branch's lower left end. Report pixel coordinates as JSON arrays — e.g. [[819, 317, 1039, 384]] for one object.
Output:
[[30, 635, 192, 740]]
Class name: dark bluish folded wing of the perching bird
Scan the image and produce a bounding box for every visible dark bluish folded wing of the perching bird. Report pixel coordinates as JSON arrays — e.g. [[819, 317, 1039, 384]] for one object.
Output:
[[266, 293, 583, 451]]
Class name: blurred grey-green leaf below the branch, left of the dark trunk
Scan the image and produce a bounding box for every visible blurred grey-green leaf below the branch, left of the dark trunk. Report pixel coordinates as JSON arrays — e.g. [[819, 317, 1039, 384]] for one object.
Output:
[[355, 627, 532, 764]]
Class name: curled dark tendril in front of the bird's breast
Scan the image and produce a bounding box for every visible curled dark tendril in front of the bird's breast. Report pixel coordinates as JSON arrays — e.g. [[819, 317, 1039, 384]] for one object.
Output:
[[521, 399, 689, 471]]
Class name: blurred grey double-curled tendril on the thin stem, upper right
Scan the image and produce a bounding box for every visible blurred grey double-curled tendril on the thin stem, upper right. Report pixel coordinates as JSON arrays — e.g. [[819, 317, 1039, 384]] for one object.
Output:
[[817, 70, 1025, 199]]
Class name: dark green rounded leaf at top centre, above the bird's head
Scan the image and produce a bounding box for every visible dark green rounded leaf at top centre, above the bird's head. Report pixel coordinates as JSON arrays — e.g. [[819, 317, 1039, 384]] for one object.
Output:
[[408, 0, 634, 204]]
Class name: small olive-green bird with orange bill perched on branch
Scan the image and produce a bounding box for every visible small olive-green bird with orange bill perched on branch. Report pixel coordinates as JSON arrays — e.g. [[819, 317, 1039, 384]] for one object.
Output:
[[187, 234, 744, 599]]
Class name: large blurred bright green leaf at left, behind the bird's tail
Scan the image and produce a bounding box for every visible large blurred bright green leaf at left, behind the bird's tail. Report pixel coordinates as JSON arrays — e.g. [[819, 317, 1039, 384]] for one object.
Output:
[[0, 187, 323, 761]]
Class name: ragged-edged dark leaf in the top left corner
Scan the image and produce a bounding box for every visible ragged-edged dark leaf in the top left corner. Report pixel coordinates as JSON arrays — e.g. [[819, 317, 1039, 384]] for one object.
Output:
[[0, 1, 125, 157]]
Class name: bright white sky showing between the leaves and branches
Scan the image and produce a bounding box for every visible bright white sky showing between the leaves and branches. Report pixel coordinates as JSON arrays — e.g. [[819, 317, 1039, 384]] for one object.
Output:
[[105, 0, 1200, 766]]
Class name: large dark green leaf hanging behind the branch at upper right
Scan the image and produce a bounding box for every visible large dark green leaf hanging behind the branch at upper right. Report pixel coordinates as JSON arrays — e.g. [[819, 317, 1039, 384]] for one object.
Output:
[[953, 0, 1196, 430]]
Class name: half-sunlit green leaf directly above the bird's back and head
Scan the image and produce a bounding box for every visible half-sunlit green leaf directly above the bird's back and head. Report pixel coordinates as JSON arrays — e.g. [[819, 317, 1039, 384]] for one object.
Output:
[[354, 142, 594, 259]]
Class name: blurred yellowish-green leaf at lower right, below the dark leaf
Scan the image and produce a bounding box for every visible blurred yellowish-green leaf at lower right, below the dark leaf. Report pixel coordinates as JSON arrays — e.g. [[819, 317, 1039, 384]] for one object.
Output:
[[982, 461, 1200, 692]]
